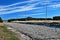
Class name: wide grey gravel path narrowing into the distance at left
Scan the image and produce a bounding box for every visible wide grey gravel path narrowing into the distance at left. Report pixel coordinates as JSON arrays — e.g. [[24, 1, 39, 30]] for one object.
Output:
[[5, 23, 60, 40]]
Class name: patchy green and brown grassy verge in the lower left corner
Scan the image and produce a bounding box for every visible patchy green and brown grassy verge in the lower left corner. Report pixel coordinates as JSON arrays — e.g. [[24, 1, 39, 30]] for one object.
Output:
[[0, 23, 20, 40]]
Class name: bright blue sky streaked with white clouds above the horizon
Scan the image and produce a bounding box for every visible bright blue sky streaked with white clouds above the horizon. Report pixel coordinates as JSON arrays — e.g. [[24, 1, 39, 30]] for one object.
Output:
[[0, 0, 60, 20]]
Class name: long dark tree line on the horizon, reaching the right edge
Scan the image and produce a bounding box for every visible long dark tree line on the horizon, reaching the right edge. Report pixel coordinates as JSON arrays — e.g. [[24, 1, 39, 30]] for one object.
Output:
[[8, 16, 60, 22]]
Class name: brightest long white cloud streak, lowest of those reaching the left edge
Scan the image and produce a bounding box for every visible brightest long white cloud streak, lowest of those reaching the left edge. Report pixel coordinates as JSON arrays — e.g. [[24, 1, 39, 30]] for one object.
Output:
[[0, 7, 39, 15]]
